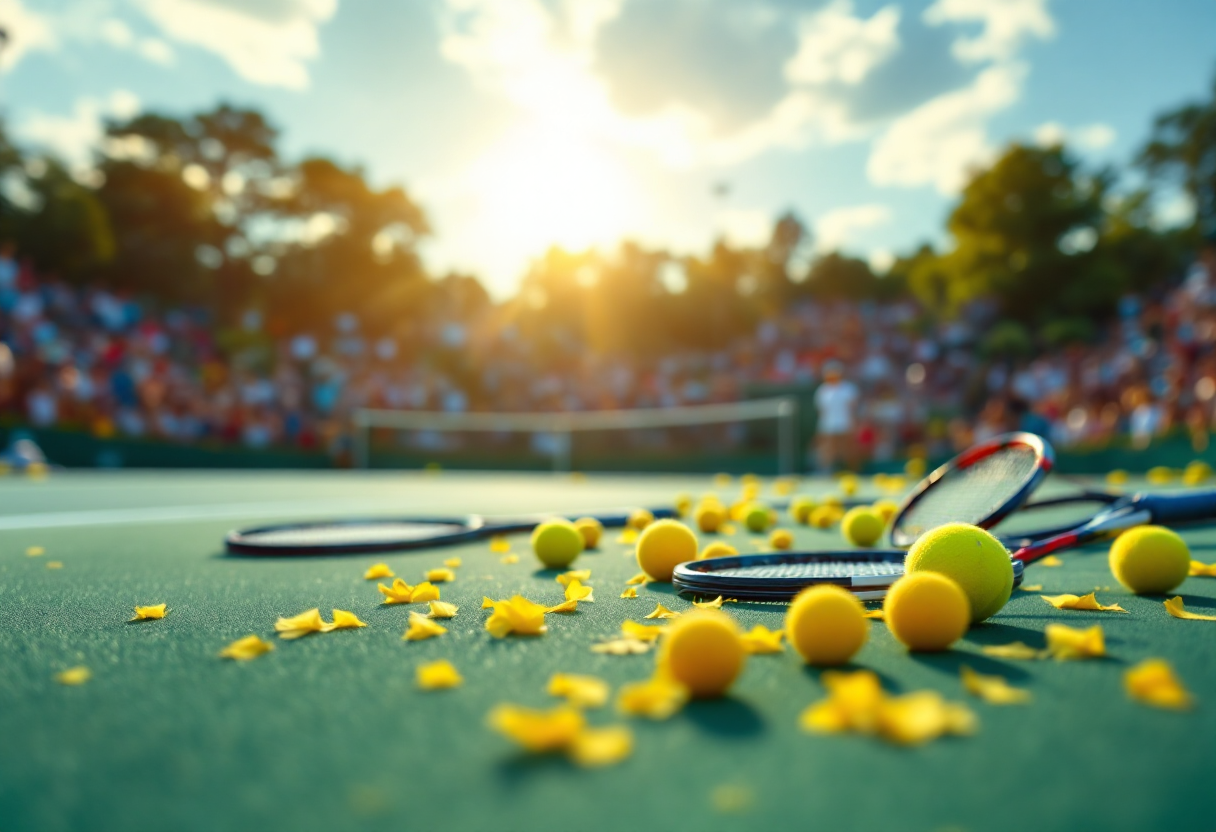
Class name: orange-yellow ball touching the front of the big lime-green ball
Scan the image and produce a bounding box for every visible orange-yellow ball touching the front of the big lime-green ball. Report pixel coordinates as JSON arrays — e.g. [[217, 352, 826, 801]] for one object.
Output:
[[883, 572, 972, 652]]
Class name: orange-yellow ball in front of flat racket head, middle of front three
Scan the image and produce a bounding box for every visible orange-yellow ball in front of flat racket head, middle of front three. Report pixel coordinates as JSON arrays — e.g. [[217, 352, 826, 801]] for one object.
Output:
[[786, 584, 869, 665]]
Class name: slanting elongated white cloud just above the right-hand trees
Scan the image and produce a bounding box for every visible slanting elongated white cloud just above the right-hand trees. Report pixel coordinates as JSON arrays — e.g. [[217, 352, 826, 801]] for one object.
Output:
[[866, 64, 1025, 195]]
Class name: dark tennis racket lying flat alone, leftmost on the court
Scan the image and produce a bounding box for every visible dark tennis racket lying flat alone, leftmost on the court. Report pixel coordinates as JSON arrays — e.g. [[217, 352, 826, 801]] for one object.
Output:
[[224, 508, 675, 555]]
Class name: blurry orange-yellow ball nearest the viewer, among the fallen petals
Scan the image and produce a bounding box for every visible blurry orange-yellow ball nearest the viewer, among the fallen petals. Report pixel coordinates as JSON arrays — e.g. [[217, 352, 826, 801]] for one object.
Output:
[[658, 609, 748, 699]]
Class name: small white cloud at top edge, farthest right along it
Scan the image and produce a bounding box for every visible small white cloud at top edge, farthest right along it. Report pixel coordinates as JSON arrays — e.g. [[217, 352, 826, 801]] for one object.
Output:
[[924, 0, 1055, 63]]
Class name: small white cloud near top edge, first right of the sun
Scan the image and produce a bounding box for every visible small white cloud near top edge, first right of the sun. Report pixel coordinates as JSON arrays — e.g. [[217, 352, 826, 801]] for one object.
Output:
[[786, 0, 900, 84]]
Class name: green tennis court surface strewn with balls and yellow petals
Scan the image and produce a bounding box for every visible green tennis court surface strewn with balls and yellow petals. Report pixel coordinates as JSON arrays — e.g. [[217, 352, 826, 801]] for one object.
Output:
[[0, 473, 1216, 832]]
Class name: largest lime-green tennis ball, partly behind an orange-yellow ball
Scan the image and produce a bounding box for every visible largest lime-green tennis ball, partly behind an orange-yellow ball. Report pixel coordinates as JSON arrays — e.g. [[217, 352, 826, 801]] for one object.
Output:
[[903, 523, 1013, 623]]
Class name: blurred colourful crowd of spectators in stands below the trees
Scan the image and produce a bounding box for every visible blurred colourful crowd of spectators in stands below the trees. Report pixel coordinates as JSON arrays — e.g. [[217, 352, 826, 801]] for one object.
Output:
[[0, 247, 1216, 463]]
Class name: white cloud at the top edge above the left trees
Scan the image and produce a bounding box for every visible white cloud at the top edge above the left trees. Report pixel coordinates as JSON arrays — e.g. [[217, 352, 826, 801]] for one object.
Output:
[[135, 0, 338, 89]]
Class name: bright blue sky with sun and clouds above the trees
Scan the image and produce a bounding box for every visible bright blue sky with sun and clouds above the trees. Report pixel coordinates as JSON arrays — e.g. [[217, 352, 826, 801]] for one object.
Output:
[[0, 0, 1216, 298]]
